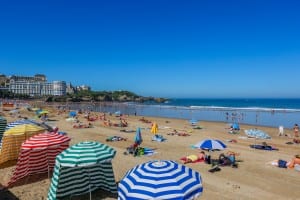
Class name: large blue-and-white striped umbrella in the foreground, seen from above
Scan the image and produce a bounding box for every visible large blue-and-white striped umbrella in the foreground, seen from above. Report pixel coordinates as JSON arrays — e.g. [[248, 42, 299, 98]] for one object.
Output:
[[118, 160, 203, 200]]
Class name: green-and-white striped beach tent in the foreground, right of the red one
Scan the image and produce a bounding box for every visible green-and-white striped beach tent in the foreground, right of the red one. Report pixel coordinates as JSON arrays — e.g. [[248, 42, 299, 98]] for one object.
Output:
[[47, 141, 117, 200]]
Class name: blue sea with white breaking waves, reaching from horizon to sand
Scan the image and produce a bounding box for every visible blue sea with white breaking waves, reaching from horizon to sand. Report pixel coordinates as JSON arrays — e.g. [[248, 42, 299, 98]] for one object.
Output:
[[62, 98, 300, 128]]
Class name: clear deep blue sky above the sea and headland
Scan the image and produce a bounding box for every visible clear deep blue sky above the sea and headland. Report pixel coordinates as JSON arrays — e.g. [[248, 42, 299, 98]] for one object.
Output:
[[0, 0, 300, 98]]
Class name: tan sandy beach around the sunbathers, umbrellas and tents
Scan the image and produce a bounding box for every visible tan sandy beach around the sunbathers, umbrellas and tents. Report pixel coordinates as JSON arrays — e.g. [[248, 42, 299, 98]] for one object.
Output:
[[0, 105, 300, 200]]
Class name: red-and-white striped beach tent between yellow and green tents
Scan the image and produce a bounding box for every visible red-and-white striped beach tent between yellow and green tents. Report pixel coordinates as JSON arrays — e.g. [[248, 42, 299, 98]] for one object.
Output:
[[8, 133, 71, 186]]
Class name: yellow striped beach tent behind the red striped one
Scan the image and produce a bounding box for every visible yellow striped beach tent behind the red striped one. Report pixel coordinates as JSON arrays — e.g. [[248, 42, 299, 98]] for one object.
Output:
[[0, 124, 45, 164]]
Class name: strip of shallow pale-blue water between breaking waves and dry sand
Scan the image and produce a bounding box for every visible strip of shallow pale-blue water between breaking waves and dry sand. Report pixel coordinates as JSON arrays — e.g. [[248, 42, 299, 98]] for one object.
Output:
[[2, 100, 300, 128]]
